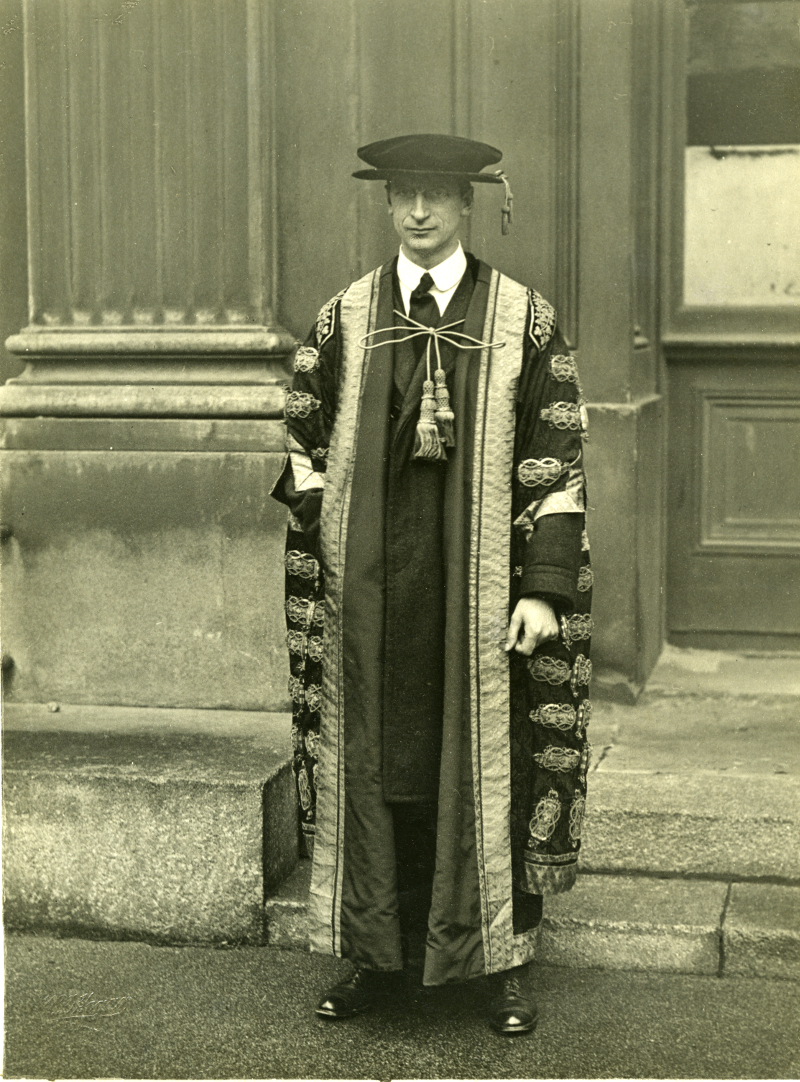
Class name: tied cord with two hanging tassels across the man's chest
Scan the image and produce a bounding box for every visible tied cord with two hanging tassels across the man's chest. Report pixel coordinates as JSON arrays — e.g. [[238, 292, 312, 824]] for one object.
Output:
[[358, 308, 506, 462]]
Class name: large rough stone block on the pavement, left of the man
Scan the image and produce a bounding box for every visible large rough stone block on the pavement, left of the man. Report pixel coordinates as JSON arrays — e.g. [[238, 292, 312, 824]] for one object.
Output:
[[3, 703, 298, 942]]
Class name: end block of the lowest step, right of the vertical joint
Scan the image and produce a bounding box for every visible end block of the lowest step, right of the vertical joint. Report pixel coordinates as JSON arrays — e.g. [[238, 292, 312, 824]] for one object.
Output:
[[723, 883, 800, 980]]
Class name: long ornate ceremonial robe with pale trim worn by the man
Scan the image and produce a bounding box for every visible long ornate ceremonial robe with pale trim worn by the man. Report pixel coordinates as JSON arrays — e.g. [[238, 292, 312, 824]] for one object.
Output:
[[274, 258, 592, 985]]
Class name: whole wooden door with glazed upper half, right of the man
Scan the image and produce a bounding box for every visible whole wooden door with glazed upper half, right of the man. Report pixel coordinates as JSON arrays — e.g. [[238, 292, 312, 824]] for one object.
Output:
[[665, 0, 800, 649]]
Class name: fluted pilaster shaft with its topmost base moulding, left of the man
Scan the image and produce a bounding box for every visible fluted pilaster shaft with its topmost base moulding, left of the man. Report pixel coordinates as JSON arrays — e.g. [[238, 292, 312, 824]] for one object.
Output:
[[2, 0, 291, 411]]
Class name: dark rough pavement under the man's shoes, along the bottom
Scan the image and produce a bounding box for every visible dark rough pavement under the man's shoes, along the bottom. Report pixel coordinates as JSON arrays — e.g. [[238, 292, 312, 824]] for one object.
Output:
[[3, 936, 800, 1079]]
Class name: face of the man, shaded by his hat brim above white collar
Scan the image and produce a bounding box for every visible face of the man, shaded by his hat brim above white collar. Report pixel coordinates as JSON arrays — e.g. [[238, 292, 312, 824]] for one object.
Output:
[[389, 176, 472, 267]]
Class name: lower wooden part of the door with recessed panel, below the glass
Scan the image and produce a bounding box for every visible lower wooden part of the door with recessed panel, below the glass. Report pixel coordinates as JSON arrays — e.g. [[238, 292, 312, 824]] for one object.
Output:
[[667, 356, 800, 649]]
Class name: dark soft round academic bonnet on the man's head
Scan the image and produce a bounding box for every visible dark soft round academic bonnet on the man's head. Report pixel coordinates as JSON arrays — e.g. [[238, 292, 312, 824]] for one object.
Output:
[[353, 135, 502, 184]]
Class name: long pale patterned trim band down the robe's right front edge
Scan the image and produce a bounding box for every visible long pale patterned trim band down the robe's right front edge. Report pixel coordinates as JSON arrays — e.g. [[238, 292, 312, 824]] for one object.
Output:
[[465, 271, 535, 973]]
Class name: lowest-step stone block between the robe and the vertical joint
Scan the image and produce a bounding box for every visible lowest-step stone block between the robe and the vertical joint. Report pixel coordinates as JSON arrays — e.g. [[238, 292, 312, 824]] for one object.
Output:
[[537, 875, 727, 976]]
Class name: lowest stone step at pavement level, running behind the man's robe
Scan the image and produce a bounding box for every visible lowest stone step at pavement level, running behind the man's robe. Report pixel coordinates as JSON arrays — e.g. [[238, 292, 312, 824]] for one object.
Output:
[[266, 860, 800, 980]]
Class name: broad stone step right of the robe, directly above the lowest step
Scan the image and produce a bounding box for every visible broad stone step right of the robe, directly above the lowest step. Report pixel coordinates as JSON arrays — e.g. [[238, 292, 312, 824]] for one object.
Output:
[[581, 697, 800, 883]]
